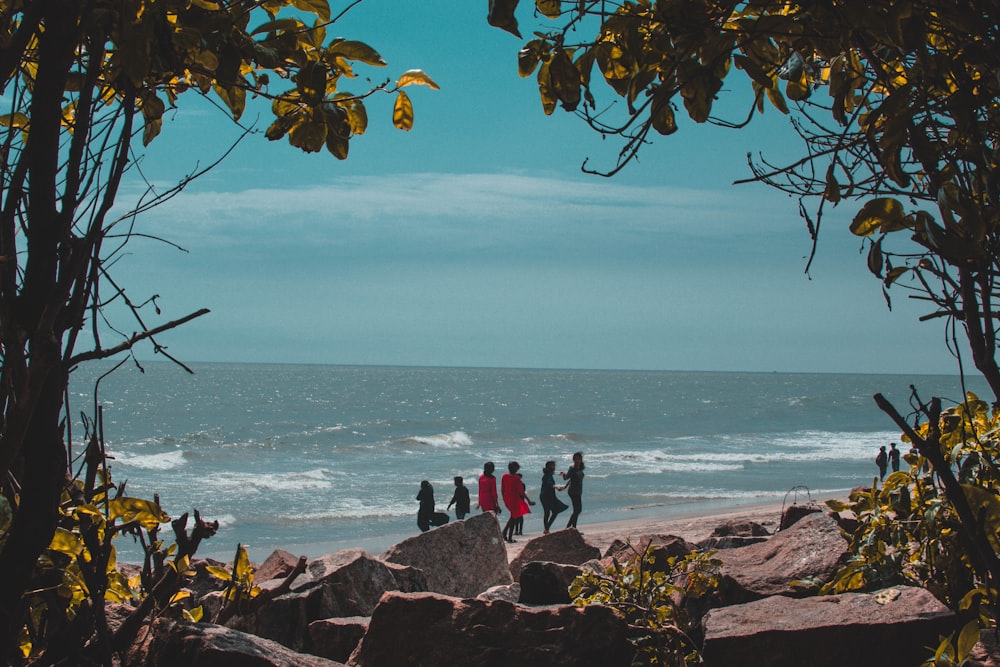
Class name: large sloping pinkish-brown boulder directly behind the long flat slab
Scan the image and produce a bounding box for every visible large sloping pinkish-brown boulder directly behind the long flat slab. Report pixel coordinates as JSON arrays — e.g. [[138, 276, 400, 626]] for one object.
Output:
[[715, 512, 848, 604]]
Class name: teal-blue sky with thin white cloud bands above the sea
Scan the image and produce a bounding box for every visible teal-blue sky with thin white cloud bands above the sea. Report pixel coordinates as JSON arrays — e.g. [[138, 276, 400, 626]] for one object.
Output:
[[103, 0, 956, 373]]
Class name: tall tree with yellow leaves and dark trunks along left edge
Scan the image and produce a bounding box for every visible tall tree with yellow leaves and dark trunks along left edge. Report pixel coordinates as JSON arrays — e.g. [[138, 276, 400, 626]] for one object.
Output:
[[0, 0, 437, 664]]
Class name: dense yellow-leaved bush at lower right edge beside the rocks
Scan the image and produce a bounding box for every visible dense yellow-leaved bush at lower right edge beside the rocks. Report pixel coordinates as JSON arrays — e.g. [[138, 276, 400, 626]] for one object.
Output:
[[822, 392, 1000, 666]]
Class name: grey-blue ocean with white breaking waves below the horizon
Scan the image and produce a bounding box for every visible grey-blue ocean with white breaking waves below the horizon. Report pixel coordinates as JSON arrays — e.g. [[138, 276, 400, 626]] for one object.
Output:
[[70, 362, 989, 561]]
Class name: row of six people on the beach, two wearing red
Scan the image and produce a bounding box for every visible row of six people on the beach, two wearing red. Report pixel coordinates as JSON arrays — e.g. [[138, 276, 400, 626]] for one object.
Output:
[[417, 452, 584, 542]]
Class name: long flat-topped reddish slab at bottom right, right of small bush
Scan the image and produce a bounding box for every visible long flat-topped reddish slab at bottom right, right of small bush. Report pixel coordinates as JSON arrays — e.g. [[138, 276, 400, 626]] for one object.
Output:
[[702, 586, 955, 667]]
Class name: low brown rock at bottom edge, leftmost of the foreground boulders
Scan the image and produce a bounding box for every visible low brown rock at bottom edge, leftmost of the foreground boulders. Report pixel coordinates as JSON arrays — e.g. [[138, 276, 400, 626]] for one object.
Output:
[[122, 618, 343, 667]]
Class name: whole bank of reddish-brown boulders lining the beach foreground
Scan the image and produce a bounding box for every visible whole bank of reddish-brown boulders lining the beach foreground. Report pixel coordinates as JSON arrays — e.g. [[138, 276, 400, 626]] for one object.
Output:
[[111, 501, 996, 667]]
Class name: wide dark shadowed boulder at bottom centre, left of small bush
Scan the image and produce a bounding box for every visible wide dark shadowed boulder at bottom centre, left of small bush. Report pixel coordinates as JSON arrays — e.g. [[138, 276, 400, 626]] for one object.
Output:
[[347, 593, 633, 667]]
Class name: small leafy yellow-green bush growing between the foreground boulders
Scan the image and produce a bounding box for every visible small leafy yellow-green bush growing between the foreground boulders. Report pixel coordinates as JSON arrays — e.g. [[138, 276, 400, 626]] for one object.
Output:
[[569, 543, 721, 667]]
